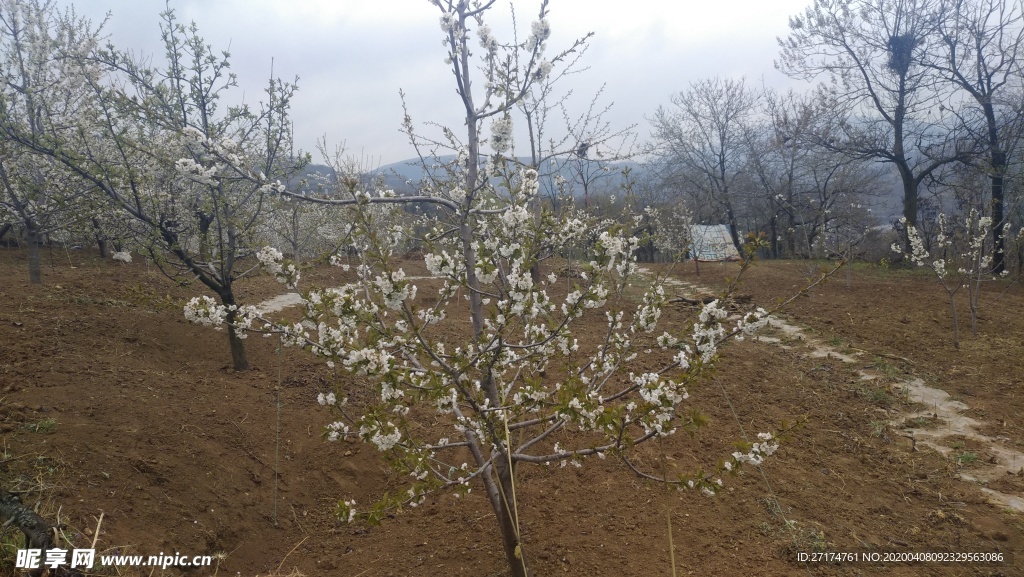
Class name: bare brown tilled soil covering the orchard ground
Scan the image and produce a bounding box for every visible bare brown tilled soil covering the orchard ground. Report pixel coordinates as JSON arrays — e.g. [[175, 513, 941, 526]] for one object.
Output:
[[0, 249, 1024, 577]]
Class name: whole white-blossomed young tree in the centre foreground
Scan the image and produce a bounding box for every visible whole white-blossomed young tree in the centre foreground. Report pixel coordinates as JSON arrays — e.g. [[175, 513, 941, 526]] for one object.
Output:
[[182, 0, 777, 577]]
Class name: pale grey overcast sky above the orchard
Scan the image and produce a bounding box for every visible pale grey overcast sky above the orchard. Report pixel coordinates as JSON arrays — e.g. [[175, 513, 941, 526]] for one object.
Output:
[[58, 0, 811, 165]]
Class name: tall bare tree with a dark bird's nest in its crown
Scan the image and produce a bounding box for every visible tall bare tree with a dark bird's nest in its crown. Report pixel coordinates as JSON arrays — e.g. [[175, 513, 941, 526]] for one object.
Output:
[[775, 0, 973, 235]]
